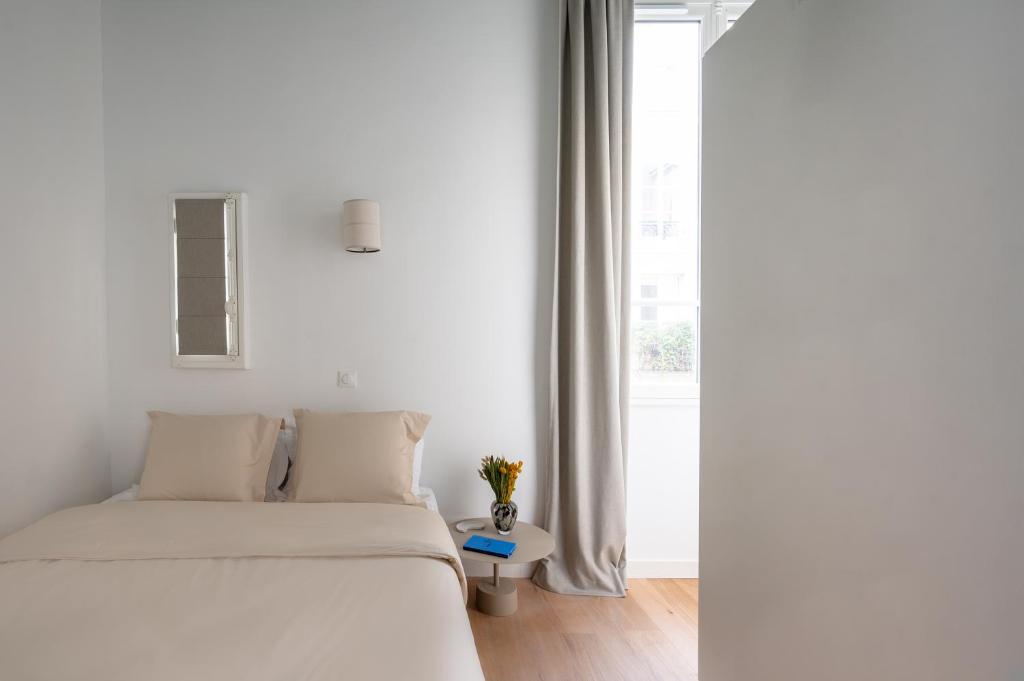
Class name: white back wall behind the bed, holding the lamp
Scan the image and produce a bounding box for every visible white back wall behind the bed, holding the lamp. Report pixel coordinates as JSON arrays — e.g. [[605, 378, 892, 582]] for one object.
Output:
[[103, 0, 558, 520]]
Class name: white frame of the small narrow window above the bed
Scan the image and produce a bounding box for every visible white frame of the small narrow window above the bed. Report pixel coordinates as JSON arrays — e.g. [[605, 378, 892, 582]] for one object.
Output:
[[168, 191, 250, 369]]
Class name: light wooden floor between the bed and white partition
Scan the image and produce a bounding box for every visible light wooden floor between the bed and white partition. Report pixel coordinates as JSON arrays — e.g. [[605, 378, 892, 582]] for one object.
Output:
[[469, 580, 697, 681]]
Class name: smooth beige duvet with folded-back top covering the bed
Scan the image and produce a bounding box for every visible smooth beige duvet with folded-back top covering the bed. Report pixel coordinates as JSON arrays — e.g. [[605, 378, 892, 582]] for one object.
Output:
[[0, 501, 483, 681]]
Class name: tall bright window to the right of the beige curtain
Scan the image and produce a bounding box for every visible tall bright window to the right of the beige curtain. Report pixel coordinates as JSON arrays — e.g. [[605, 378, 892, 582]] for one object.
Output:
[[631, 1, 749, 400]]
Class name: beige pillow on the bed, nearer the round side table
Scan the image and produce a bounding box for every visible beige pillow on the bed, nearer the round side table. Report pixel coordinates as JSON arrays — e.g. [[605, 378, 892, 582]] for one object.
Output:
[[289, 409, 430, 506]]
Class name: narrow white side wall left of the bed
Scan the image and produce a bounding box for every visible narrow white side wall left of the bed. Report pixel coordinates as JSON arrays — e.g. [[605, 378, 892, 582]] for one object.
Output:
[[0, 0, 111, 537]]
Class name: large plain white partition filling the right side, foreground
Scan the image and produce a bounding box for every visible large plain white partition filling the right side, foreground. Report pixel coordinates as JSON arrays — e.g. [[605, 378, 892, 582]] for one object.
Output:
[[700, 0, 1024, 681]]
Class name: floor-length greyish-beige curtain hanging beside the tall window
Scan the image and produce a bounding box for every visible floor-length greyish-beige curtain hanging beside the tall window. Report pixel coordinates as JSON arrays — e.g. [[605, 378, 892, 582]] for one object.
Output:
[[534, 0, 633, 596]]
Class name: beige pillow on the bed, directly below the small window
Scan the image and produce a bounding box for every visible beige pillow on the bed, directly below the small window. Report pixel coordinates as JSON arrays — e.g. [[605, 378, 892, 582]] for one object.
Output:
[[138, 412, 281, 502]]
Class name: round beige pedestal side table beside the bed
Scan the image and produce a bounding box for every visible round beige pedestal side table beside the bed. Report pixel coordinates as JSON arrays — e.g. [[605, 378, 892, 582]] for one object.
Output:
[[449, 518, 555, 616]]
